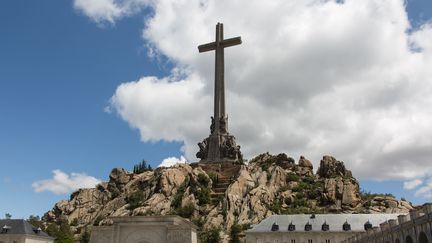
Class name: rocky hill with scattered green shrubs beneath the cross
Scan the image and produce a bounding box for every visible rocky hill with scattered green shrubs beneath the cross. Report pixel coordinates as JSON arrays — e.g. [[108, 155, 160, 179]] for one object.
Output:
[[43, 153, 412, 241]]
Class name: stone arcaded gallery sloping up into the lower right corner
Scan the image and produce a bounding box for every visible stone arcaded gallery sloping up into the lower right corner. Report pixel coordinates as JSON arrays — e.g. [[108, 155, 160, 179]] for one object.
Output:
[[343, 203, 432, 243]]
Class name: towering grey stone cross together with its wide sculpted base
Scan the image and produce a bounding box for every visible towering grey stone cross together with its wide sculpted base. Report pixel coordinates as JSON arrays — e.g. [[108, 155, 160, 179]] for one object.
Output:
[[196, 23, 243, 162]]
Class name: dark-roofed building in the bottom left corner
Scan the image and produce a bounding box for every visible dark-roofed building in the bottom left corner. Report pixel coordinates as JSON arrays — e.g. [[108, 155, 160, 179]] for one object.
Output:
[[0, 219, 54, 243]]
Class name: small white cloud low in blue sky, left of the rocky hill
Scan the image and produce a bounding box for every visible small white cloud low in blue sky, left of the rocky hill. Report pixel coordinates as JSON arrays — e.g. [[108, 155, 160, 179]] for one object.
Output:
[[32, 170, 101, 194]]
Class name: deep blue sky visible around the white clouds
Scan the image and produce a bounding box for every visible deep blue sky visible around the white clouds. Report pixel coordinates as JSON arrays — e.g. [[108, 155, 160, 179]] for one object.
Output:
[[0, 0, 432, 217]]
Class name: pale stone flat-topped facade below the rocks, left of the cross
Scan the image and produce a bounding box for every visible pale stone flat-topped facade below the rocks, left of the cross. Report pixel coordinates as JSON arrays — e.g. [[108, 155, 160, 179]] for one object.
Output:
[[90, 216, 197, 243]]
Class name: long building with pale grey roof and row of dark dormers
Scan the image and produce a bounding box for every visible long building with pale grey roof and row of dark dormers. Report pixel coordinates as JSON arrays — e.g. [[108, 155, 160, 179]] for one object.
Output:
[[245, 214, 399, 243]]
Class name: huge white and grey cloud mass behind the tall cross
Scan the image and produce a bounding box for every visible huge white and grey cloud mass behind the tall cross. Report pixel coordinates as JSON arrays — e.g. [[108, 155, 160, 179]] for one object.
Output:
[[79, 0, 432, 180]]
